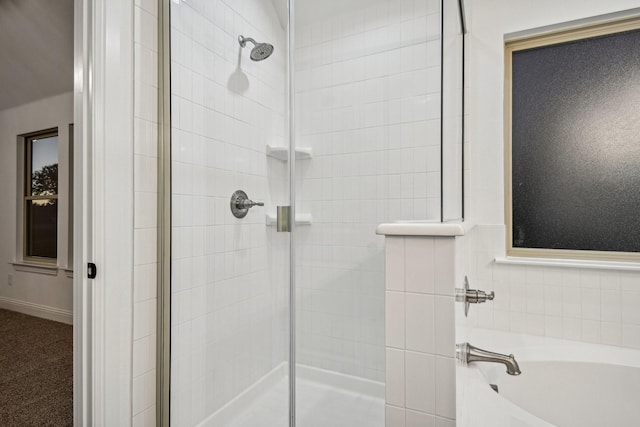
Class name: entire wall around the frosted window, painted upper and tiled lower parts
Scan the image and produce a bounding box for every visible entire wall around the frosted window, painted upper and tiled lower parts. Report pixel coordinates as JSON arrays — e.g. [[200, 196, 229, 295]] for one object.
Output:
[[463, 0, 640, 348]]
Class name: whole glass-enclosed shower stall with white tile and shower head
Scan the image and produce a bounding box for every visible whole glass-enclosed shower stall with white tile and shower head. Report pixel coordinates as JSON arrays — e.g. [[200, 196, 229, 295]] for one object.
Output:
[[159, 0, 465, 427]]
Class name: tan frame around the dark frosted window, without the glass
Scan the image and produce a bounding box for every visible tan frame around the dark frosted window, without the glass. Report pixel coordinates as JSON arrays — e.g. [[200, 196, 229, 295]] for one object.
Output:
[[504, 16, 640, 262]]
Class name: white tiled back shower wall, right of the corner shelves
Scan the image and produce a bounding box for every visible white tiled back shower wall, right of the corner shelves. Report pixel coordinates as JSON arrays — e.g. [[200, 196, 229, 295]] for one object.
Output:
[[294, 0, 440, 381]]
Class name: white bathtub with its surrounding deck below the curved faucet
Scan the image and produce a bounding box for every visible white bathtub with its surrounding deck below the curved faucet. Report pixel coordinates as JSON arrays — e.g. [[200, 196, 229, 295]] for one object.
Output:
[[456, 329, 640, 427]]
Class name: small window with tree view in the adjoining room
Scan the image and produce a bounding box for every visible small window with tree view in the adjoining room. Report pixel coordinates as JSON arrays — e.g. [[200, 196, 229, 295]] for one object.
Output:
[[24, 130, 58, 262]]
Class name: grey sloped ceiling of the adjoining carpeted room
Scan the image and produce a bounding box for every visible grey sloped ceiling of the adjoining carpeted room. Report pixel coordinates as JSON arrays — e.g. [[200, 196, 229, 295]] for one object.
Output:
[[0, 0, 73, 110]]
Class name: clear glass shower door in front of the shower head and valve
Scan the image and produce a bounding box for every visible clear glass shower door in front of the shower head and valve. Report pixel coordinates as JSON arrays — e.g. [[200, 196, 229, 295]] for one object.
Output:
[[170, 0, 290, 427]]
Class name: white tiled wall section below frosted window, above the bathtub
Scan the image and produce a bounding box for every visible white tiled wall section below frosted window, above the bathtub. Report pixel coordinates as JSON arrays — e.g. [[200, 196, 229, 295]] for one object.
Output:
[[458, 225, 640, 348]]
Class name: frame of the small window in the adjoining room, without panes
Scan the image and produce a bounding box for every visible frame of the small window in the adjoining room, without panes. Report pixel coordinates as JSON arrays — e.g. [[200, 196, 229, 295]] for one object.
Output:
[[21, 127, 60, 264]]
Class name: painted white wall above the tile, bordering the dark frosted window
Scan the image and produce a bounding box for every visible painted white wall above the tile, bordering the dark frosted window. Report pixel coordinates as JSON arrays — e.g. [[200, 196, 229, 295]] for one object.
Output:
[[465, 0, 640, 224]]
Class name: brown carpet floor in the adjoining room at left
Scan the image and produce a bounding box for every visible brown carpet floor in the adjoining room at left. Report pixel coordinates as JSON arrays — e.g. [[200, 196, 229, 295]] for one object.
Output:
[[0, 309, 73, 427]]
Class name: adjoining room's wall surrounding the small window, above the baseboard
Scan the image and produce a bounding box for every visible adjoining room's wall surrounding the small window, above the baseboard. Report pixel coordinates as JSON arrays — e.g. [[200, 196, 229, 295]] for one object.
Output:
[[0, 93, 73, 323]]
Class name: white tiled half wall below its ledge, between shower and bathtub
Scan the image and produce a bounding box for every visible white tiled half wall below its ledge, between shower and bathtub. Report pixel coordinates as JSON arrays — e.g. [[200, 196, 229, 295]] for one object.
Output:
[[386, 236, 457, 427]]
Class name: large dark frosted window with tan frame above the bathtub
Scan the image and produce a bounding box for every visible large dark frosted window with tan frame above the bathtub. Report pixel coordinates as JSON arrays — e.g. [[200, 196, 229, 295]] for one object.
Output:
[[505, 19, 640, 260]]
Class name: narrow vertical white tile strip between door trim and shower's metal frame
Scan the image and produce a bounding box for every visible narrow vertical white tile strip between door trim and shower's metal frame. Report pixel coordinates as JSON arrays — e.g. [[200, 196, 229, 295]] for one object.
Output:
[[132, 0, 158, 427]]
